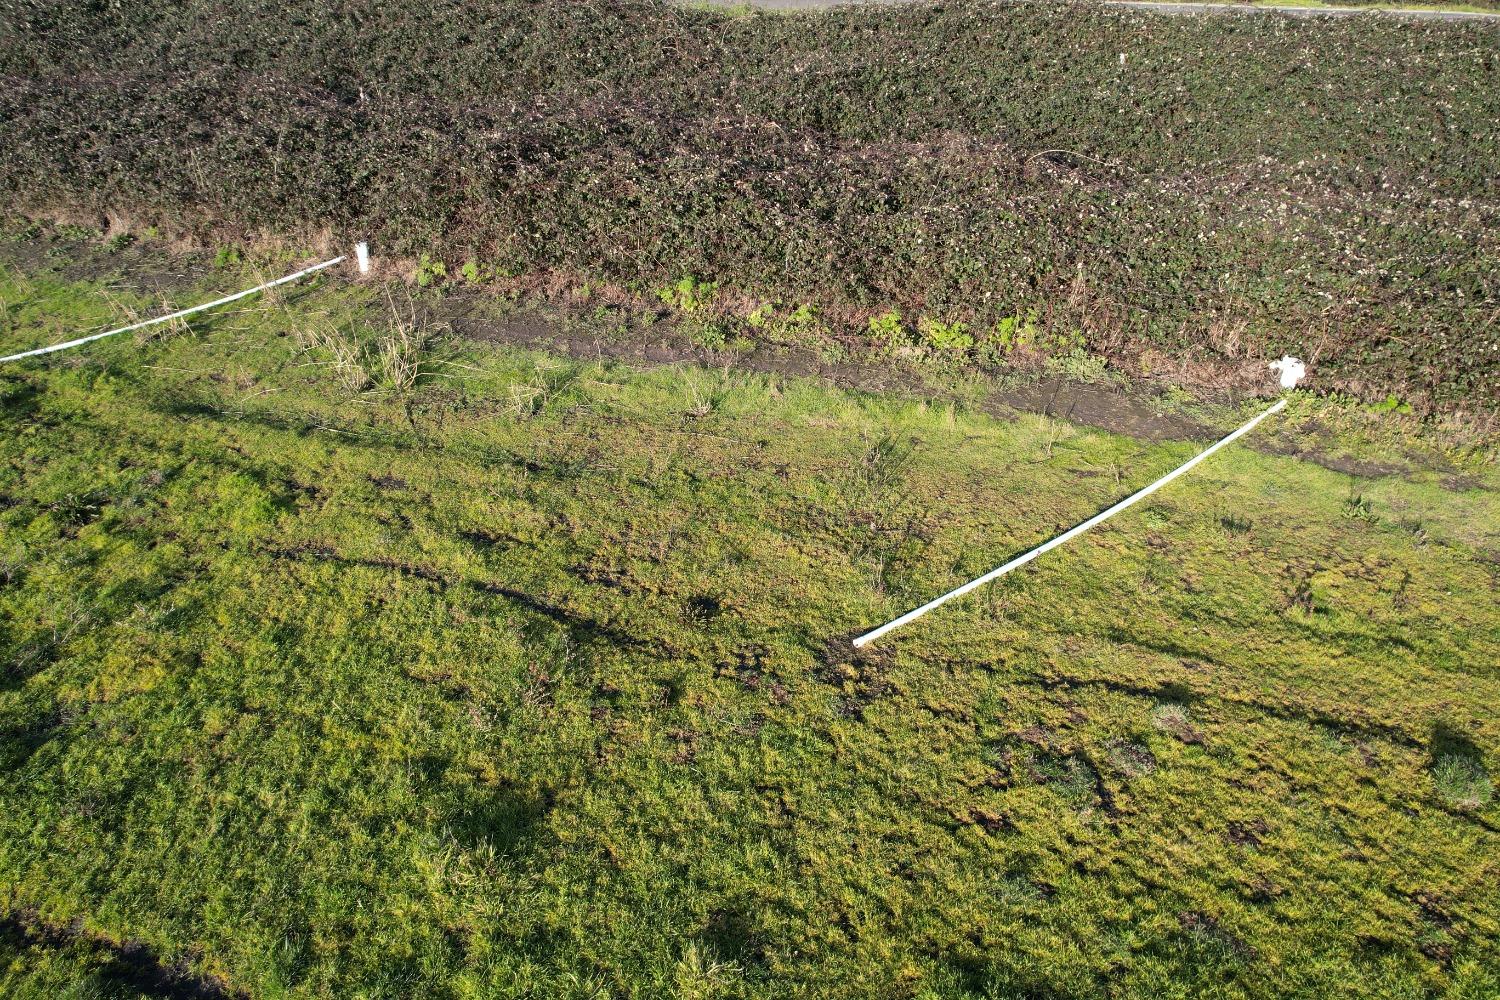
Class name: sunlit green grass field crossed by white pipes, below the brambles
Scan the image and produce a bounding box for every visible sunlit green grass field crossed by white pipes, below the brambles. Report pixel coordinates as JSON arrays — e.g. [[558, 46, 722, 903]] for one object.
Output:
[[0, 230, 1500, 1000]]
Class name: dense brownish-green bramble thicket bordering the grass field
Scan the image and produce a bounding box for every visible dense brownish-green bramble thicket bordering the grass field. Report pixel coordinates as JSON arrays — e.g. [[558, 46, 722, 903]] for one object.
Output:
[[0, 0, 1500, 406]]
